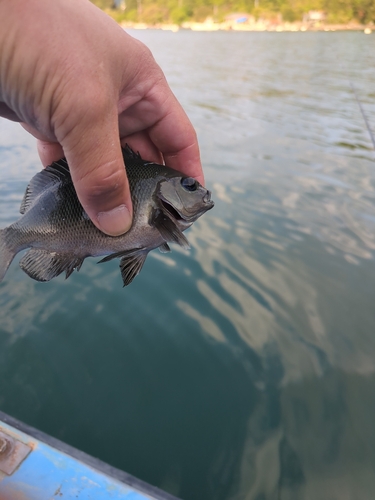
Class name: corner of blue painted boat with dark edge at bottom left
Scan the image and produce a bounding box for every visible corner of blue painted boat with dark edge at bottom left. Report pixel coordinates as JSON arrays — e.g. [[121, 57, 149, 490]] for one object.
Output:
[[0, 412, 177, 500]]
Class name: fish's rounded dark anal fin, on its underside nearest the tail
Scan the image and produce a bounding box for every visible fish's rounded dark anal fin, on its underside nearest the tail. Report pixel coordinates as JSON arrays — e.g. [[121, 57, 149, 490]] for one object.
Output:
[[20, 248, 84, 281]]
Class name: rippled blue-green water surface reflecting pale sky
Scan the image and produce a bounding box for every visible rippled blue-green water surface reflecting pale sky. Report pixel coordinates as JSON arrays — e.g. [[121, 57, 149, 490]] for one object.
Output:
[[0, 31, 375, 500]]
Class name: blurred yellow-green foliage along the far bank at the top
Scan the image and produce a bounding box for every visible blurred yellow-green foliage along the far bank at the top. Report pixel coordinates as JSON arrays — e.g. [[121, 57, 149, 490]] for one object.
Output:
[[91, 0, 375, 24]]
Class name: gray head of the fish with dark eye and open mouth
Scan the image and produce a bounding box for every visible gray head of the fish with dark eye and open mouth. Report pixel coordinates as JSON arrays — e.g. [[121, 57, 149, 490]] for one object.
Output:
[[157, 176, 214, 228]]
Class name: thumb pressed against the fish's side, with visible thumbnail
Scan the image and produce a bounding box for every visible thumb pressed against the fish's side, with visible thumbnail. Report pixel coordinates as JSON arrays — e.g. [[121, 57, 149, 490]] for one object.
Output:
[[59, 109, 132, 236]]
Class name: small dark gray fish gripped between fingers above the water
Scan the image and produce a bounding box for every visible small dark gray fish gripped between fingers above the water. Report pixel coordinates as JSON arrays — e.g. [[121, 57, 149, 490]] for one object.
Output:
[[0, 146, 214, 286]]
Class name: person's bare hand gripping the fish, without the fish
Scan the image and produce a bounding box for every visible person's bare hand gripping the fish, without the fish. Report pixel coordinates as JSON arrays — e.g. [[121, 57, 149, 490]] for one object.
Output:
[[0, 0, 204, 236]]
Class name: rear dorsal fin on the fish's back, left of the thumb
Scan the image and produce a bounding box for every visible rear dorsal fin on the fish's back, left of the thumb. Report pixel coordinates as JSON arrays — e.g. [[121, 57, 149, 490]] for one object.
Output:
[[20, 158, 71, 214]]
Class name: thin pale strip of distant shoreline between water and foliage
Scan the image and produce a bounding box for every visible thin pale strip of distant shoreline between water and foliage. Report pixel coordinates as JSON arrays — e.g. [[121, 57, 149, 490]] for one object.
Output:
[[121, 21, 375, 35]]
